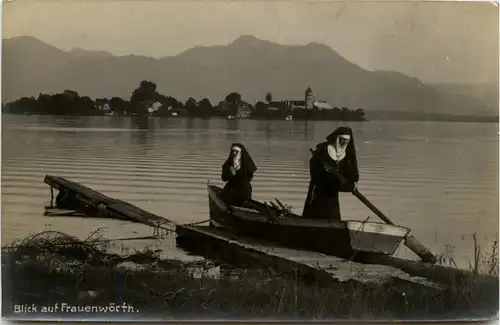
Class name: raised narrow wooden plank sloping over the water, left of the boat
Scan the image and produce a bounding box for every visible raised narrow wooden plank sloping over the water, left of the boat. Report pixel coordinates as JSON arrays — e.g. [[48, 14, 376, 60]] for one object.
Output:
[[44, 175, 173, 228]]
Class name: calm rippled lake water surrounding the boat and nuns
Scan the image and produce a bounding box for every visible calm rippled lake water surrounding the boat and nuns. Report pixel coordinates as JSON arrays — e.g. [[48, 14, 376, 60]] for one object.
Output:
[[2, 115, 499, 265]]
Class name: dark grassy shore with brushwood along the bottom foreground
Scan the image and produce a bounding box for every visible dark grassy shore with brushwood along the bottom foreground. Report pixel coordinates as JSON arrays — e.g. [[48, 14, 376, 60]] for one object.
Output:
[[2, 232, 498, 320]]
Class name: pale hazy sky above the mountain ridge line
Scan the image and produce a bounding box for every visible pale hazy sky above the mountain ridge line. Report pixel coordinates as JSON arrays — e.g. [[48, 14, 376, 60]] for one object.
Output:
[[3, 0, 499, 83]]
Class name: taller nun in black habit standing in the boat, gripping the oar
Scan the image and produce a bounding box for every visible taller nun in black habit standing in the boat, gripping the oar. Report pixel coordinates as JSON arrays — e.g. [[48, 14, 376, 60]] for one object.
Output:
[[302, 127, 359, 220]]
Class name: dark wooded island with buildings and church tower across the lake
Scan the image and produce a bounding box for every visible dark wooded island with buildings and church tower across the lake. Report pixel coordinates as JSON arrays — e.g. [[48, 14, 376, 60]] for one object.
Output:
[[2, 80, 366, 121]]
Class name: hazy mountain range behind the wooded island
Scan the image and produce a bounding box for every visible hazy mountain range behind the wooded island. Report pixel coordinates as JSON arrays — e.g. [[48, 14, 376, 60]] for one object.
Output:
[[2, 35, 497, 118]]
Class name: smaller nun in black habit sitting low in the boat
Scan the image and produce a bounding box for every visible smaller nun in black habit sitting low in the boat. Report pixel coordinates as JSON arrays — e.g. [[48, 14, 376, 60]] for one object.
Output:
[[222, 143, 257, 206]]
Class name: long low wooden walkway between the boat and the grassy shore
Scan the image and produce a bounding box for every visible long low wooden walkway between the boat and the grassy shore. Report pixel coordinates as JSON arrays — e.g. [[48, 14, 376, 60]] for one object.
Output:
[[176, 225, 439, 289]]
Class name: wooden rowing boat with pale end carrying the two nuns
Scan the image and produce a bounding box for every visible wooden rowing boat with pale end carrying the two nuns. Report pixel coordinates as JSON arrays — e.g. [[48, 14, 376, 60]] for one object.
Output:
[[207, 183, 410, 257]]
